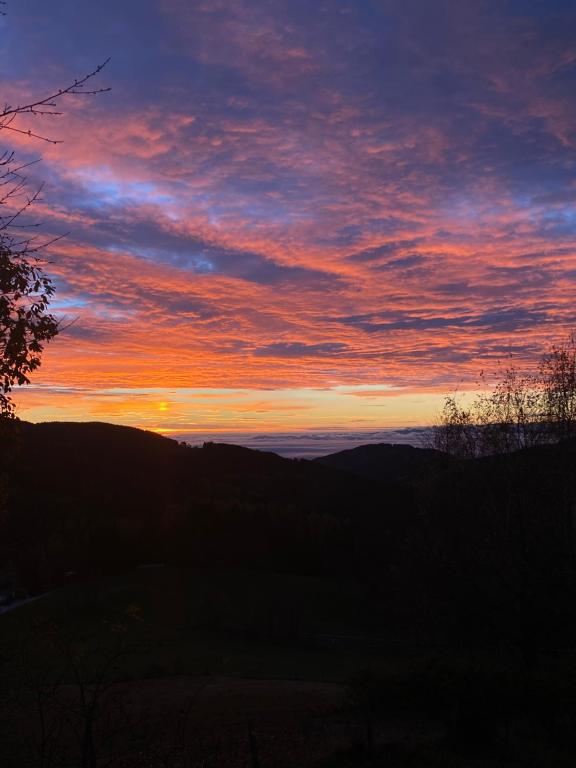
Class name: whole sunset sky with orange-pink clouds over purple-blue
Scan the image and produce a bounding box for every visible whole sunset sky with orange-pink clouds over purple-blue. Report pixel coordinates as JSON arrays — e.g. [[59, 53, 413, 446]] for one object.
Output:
[[0, 0, 576, 435]]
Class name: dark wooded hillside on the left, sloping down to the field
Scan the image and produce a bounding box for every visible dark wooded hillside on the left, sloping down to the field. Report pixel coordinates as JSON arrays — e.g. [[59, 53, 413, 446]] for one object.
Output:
[[0, 423, 411, 592]]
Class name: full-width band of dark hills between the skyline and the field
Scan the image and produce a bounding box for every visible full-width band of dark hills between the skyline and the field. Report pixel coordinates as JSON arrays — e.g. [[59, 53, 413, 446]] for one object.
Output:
[[5, 423, 576, 643]]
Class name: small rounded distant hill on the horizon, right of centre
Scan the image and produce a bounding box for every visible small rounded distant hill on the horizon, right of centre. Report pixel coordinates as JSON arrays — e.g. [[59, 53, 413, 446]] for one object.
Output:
[[316, 443, 456, 483]]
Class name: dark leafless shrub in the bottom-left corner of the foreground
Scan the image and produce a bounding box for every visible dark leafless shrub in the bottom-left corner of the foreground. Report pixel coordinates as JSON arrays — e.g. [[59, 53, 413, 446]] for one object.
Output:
[[5, 605, 156, 768]]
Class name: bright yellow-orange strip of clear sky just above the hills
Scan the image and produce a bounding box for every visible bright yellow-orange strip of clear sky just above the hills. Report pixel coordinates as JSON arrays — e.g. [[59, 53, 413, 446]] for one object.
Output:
[[11, 385, 454, 435]]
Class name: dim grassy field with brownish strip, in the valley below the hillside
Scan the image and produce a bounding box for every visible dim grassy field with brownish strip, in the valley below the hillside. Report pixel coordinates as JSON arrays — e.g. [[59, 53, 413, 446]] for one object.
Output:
[[0, 565, 452, 766]]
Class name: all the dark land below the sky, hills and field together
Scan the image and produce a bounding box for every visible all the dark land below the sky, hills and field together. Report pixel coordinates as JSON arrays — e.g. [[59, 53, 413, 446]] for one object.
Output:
[[0, 421, 576, 768]]
